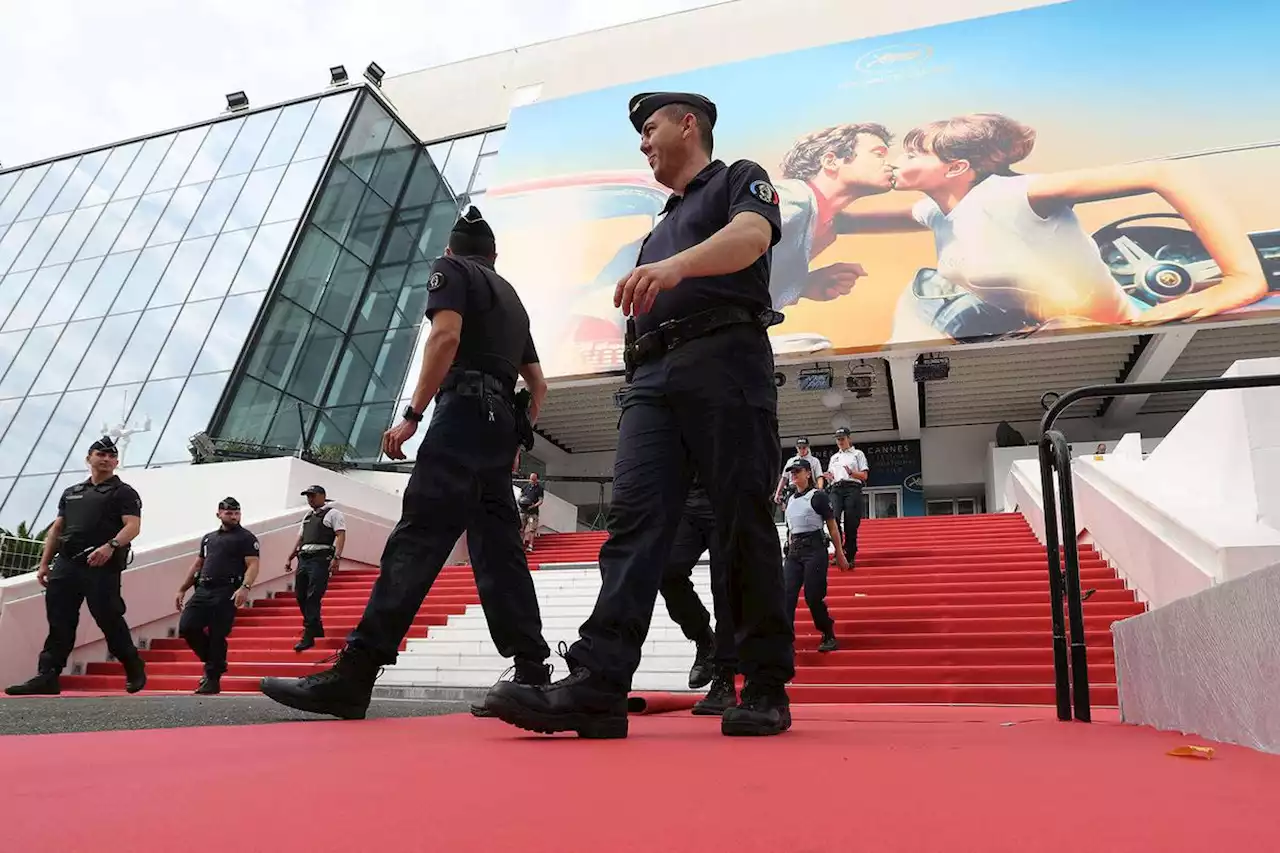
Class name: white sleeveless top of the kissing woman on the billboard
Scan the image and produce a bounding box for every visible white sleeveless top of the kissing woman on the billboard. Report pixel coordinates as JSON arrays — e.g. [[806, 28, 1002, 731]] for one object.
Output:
[[911, 175, 1137, 323]]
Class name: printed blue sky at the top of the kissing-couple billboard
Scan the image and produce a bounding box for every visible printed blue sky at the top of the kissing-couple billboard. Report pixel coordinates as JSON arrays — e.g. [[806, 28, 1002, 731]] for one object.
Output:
[[497, 0, 1280, 183]]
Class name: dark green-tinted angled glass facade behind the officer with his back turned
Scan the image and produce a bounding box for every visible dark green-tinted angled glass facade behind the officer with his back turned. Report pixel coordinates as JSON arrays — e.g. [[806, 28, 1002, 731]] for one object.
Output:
[[211, 95, 500, 461]]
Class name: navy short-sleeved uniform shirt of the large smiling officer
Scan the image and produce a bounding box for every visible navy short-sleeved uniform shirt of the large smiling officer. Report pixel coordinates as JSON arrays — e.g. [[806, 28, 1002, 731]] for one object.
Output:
[[636, 160, 782, 334]]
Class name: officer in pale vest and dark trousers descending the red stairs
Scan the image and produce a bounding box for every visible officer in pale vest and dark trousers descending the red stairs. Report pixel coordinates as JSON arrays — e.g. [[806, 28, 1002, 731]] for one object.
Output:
[[782, 460, 849, 652]]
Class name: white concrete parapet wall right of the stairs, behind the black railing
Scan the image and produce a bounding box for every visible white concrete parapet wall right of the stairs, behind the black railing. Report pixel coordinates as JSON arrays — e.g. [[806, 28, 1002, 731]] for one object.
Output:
[[1005, 359, 1280, 608]]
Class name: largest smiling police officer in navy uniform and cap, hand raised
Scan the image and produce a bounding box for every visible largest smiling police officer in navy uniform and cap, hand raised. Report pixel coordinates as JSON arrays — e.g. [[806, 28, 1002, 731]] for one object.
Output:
[[489, 92, 795, 738]]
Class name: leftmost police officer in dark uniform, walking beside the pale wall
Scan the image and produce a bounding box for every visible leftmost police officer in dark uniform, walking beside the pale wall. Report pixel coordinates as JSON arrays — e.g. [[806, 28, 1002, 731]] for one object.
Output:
[[5, 437, 147, 695]]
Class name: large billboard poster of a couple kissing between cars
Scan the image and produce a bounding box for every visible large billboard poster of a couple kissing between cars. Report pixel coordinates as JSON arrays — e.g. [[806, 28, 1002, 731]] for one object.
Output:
[[484, 0, 1280, 377]]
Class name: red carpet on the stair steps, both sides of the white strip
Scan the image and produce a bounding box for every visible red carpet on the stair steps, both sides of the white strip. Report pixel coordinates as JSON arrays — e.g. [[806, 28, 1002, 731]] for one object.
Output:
[[63, 514, 1144, 706]]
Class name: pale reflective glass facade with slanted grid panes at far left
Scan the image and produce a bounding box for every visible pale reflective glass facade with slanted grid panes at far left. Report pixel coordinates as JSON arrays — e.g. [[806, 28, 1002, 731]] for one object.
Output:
[[0, 90, 355, 529]]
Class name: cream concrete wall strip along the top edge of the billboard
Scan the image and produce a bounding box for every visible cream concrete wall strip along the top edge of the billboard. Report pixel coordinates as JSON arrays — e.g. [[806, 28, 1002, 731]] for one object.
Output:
[[383, 0, 1052, 140]]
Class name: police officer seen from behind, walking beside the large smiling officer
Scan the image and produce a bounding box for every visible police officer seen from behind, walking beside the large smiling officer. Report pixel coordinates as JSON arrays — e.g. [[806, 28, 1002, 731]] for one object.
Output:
[[262, 207, 550, 719]]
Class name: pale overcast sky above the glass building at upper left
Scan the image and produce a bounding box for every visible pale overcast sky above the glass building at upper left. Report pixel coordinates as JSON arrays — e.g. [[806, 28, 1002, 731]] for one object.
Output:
[[0, 0, 716, 167]]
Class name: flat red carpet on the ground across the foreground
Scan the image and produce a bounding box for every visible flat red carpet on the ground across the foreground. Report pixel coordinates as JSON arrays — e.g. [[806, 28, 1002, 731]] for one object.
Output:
[[0, 706, 1280, 853]]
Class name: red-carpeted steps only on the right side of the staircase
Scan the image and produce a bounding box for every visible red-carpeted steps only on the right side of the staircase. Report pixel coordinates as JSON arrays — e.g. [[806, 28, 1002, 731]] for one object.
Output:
[[790, 514, 1146, 706]]
